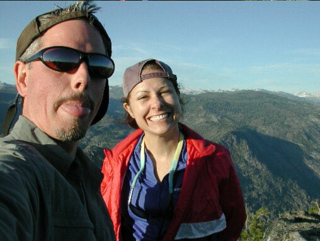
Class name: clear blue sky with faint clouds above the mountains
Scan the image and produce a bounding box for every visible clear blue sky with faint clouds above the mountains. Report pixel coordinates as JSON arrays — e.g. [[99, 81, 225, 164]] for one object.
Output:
[[0, 1, 320, 94]]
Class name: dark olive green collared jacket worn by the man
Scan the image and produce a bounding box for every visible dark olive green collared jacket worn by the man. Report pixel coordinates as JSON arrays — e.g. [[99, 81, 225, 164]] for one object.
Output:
[[0, 116, 115, 241]]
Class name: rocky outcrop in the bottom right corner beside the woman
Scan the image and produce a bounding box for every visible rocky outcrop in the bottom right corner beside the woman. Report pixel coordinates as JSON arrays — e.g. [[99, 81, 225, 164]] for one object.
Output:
[[263, 211, 320, 241]]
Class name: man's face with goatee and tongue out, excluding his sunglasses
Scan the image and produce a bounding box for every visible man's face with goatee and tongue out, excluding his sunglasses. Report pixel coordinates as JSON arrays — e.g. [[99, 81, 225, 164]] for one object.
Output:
[[16, 20, 106, 142]]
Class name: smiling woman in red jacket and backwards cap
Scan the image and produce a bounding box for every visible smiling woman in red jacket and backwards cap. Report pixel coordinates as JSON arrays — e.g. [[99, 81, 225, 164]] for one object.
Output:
[[101, 59, 246, 241]]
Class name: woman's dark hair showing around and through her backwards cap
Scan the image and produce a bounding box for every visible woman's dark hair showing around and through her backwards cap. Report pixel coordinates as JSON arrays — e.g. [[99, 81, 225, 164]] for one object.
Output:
[[121, 61, 184, 129]]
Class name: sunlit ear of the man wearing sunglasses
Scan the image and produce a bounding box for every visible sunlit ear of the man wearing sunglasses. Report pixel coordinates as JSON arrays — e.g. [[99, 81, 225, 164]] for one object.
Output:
[[13, 60, 28, 97]]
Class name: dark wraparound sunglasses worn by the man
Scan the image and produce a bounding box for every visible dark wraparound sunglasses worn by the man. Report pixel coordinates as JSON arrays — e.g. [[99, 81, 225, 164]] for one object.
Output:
[[25, 46, 115, 78]]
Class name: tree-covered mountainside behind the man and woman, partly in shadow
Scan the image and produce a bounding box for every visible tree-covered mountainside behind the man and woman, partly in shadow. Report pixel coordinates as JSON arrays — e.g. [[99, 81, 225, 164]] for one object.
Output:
[[0, 86, 320, 216]]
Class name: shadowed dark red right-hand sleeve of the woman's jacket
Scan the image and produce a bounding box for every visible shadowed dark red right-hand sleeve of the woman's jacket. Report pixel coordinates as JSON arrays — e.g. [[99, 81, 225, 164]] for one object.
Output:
[[218, 150, 246, 241]]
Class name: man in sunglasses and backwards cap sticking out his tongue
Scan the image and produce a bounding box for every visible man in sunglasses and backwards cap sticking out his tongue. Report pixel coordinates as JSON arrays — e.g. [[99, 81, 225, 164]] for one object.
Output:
[[0, 2, 115, 241]]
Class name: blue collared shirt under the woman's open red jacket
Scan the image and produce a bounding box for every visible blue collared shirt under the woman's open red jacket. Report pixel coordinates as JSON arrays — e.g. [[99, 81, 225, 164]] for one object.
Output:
[[121, 135, 187, 241]]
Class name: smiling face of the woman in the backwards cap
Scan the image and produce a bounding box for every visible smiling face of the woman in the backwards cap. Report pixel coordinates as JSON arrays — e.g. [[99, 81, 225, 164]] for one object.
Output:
[[123, 69, 181, 136]]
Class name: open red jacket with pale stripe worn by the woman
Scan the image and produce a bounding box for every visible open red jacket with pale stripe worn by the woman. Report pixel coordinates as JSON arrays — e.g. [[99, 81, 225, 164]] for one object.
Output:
[[101, 124, 246, 241]]
